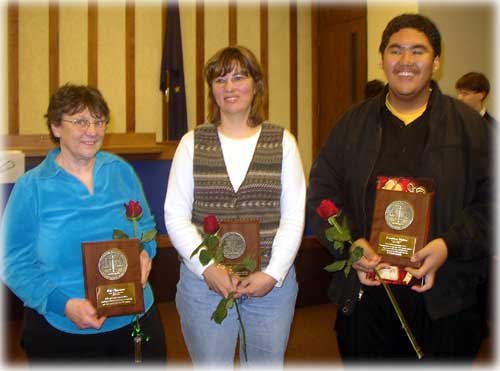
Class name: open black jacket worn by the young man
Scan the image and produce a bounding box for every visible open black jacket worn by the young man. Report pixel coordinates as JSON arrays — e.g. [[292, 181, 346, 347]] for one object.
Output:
[[307, 82, 494, 319]]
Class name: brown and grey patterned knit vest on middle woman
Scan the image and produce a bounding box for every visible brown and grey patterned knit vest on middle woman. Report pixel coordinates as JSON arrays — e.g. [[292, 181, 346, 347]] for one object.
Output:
[[192, 122, 283, 268]]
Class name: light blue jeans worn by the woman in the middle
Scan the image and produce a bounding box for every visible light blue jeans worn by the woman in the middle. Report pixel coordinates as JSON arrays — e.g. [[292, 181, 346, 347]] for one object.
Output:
[[175, 264, 298, 368]]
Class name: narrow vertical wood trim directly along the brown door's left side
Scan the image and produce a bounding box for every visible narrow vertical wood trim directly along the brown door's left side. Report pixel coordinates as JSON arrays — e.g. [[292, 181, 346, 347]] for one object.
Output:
[[311, 5, 320, 161]]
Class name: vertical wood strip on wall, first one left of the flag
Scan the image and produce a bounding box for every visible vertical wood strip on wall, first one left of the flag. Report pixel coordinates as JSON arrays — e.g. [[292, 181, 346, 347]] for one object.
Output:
[[125, 0, 135, 133]]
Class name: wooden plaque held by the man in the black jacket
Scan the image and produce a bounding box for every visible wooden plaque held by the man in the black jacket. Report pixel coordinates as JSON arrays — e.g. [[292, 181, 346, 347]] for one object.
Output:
[[370, 180, 434, 285]]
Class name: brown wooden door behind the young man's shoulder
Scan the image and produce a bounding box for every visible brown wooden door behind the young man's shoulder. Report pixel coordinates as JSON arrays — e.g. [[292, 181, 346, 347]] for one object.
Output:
[[313, 4, 367, 157]]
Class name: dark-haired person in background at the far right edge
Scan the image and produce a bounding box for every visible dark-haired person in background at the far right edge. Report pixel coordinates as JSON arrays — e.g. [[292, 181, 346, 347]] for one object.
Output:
[[455, 72, 497, 127]]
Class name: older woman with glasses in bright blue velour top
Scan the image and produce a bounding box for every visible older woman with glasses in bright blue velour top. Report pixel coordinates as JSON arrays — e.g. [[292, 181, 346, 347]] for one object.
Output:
[[2, 84, 166, 364]]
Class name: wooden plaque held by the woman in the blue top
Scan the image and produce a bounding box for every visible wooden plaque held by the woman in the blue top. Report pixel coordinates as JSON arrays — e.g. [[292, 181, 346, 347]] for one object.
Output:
[[82, 239, 144, 317]]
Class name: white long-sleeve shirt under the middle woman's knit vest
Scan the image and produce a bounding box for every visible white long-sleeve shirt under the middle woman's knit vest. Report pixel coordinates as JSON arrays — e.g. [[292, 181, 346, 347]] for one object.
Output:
[[165, 126, 306, 286]]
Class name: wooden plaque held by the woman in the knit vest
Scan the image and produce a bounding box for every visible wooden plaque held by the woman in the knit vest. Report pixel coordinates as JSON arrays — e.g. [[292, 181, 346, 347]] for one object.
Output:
[[220, 220, 260, 277]]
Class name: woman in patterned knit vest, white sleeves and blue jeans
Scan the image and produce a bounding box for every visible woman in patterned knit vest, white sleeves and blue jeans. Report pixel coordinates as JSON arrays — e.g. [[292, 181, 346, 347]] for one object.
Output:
[[165, 46, 306, 367]]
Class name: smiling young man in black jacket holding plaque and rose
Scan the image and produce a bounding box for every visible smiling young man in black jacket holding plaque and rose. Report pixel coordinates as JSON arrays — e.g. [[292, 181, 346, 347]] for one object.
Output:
[[308, 14, 494, 362]]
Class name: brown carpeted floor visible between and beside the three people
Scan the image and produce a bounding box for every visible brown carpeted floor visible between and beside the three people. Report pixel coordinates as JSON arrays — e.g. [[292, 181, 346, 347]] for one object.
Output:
[[3, 302, 495, 369]]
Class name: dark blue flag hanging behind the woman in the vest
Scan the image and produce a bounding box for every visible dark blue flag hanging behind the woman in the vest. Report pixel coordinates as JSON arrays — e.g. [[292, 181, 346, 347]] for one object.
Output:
[[160, 0, 187, 140]]
